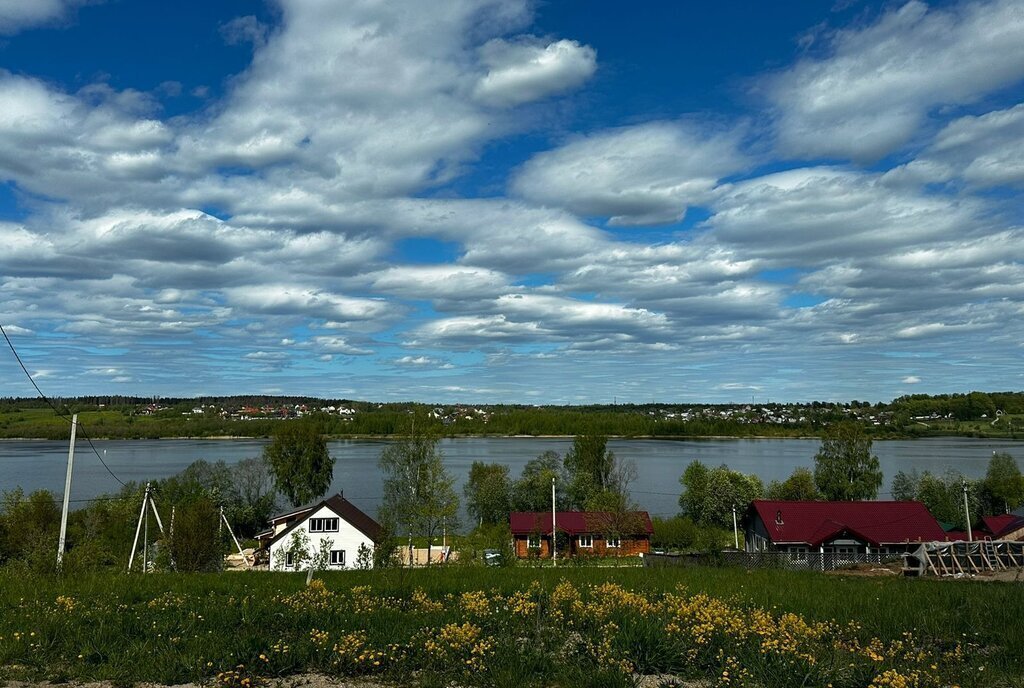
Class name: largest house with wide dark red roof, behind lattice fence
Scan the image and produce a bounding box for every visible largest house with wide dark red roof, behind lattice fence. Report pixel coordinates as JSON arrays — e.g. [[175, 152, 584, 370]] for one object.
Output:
[[743, 500, 946, 559]]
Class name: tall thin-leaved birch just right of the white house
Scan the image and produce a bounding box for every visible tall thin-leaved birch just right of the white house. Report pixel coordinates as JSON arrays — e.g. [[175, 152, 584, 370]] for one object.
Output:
[[379, 433, 459, 561]]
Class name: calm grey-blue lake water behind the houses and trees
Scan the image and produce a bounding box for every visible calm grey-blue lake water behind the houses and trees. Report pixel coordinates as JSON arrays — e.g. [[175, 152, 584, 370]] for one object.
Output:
[[0, 437, 1024, 516]]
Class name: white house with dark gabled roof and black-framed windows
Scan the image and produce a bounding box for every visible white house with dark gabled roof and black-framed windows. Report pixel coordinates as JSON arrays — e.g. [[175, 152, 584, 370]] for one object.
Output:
[[258, 495, 381, 571]]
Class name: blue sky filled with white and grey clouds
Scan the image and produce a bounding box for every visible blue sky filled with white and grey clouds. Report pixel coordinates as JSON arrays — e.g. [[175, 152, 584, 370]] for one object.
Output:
[[0, 0, 1024, 403]]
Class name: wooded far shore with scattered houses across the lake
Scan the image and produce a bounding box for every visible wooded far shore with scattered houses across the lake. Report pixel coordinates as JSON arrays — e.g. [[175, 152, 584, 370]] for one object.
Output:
[[0, 392, 1024, 439]]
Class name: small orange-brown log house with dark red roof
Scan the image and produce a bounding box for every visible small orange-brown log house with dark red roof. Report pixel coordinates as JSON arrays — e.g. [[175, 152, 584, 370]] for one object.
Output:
[[509, 511, 654, 559]]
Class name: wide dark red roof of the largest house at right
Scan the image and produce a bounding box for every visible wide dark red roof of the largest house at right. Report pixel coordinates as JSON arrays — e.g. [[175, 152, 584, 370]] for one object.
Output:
[[748, 500, 946, 547]]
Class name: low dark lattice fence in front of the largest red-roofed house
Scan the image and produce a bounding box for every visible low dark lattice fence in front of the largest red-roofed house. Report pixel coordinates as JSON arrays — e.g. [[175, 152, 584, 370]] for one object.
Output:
[[643, 550, 903, 571]]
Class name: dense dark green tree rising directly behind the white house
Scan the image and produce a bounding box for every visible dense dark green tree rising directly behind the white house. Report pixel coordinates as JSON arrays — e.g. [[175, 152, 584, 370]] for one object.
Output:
[[263, 422, 334, 507]]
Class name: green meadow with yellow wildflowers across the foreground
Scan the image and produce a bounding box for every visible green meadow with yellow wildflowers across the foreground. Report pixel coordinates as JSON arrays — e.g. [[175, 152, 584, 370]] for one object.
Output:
[[0, 568, 1024, 688]]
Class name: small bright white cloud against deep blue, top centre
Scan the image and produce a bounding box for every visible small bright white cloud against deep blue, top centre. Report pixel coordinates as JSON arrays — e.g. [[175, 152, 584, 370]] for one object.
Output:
[[474, 38, 597, 108]]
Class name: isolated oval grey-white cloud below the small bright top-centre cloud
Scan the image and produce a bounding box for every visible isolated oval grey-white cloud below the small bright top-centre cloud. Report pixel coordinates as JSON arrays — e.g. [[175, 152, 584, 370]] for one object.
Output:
[[512, 122, 745, 225]]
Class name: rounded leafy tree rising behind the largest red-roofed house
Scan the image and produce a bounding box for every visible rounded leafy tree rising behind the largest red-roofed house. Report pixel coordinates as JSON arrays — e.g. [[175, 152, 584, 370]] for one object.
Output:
[[814, 422, 882, 502]]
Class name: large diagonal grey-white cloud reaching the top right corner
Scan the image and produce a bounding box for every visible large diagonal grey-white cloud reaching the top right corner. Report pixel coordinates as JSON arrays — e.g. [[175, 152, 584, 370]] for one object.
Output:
[[766, 0, 1024, 161]]
